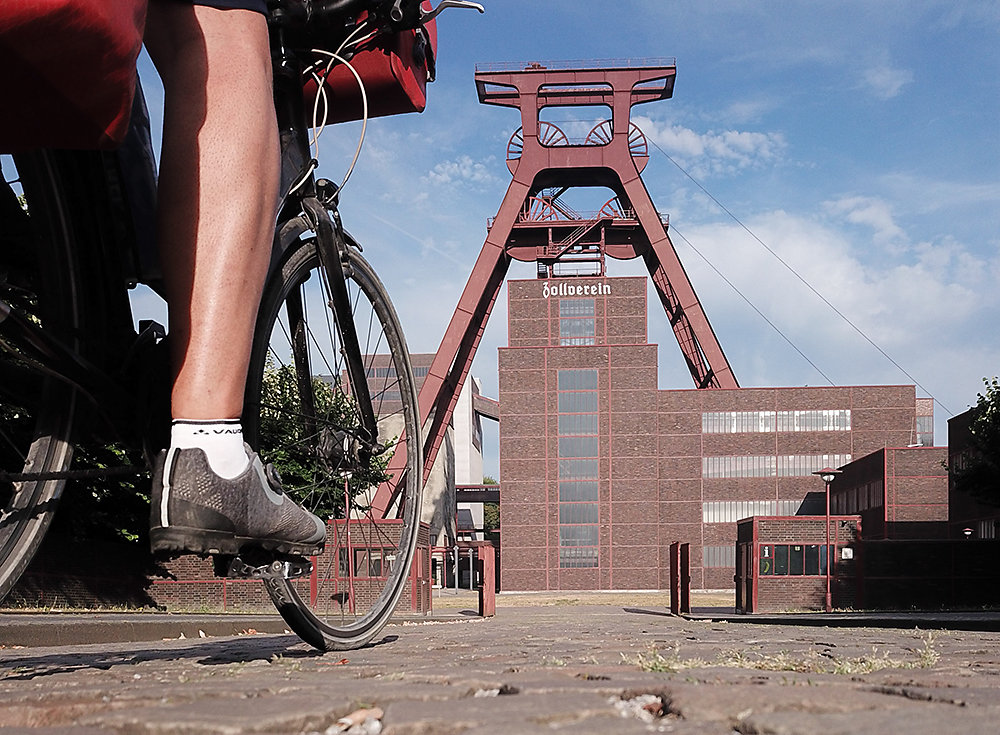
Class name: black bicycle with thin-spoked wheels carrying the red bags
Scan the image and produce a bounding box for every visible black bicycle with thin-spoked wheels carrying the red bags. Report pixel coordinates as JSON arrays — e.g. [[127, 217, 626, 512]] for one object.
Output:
[[0, 0, 482, 650]]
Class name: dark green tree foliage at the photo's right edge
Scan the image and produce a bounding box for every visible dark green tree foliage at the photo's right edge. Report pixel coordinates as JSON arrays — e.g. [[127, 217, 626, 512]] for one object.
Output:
[[949, 377, 1000, 506]]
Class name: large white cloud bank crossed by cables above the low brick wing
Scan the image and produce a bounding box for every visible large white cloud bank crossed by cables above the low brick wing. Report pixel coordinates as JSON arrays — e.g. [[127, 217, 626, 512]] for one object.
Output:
[[664, 211, 1000, 420]]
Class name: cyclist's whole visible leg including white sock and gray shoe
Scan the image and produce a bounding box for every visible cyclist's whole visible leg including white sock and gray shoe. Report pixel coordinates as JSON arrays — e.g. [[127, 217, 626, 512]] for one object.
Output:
[[146, 2, 324, 553]]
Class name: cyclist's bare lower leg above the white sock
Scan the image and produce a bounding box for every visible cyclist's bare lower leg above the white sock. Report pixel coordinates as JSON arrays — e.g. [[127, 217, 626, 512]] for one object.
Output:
[[146, 0, 279, 419]]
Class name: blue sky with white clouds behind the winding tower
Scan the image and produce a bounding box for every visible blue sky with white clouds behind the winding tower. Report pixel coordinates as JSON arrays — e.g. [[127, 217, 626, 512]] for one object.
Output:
[[141, 0, 1000, 474]]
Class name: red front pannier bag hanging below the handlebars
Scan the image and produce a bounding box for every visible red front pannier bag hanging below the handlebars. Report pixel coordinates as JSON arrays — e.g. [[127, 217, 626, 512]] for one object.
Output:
[[305, 0, 437, 123]]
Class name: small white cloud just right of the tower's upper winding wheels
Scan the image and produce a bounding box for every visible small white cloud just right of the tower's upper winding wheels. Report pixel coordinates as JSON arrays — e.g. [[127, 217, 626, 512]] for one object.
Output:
[[636, 117, 785, 176]]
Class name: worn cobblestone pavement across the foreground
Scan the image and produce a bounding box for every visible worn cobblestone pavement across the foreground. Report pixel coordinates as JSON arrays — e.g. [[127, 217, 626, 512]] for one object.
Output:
[[0, 605, 1000, 735]]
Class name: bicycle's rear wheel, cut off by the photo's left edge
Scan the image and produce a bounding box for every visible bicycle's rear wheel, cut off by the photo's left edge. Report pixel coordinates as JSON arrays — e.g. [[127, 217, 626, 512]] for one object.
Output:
[[0, 152, 84, 599]]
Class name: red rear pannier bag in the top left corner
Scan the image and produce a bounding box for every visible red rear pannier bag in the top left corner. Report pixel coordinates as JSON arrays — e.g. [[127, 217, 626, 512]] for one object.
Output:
[[0, 0, 146, 152]]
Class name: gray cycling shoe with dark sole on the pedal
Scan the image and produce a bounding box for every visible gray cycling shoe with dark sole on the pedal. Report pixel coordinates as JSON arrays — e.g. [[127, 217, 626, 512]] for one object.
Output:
[[149, 448, 326, 556]]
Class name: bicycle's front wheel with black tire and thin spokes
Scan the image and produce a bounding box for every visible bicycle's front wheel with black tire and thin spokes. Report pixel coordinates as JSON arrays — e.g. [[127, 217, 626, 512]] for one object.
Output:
[[250, 233, 422, 650]]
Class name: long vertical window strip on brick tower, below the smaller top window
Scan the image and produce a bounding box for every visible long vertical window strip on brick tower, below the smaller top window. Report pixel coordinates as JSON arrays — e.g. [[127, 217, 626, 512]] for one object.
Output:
[[556, 368, 599, 569]]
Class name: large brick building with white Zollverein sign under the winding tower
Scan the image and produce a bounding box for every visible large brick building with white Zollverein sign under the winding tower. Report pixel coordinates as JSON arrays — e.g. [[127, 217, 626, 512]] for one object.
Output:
[[499, 277, 932, 590]]
